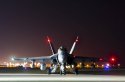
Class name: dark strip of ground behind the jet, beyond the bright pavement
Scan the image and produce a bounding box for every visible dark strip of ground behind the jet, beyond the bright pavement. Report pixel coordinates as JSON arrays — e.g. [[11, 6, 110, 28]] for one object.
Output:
[[0, 67, 125, 75]]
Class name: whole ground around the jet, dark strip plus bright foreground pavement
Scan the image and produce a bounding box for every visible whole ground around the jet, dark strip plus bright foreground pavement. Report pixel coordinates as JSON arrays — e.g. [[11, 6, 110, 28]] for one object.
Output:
[[0, 68, 125, 82]]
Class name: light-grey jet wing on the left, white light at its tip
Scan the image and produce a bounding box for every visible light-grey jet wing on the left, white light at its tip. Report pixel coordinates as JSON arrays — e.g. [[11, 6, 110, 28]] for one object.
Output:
[[12, 54, 57, 62]]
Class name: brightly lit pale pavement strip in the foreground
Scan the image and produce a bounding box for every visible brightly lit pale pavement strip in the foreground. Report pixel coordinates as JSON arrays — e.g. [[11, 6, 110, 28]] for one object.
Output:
[[0, 74, 125, 82]]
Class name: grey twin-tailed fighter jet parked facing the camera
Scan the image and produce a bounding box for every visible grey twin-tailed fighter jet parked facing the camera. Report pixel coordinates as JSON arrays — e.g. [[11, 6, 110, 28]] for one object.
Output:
[[12, 36, 98, 75]]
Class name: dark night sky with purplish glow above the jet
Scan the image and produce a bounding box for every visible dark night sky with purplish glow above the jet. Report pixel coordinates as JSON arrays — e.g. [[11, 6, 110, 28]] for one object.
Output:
[[0, 0, 125, 65]]
